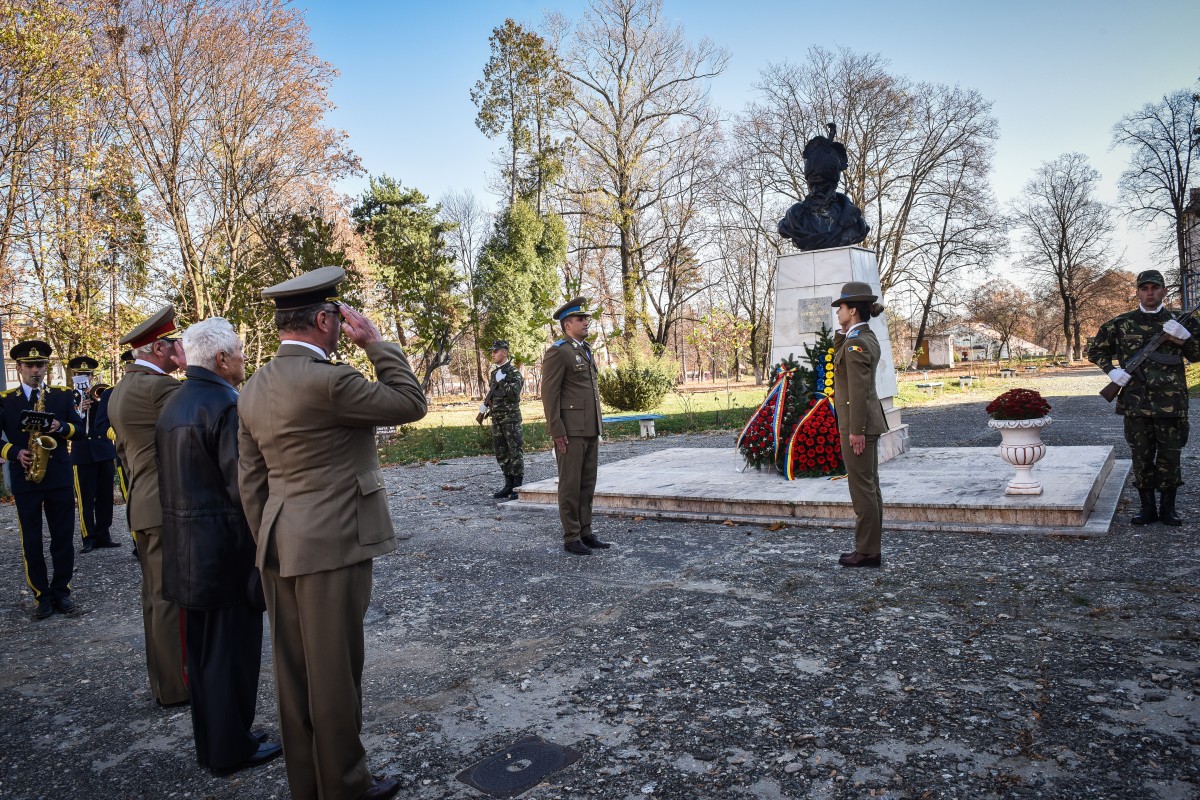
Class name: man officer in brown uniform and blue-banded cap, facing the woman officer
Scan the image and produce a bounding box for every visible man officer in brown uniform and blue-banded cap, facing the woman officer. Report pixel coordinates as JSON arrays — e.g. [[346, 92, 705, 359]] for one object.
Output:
[[541, 297, 610, 555]]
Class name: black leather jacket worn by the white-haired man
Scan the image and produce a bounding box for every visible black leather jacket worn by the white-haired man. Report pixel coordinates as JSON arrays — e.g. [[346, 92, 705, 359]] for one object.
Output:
[[156, 367, 254, 609]]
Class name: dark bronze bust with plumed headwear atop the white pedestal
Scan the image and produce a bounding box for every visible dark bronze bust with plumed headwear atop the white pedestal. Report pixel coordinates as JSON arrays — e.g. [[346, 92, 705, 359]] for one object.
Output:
[[779, 122, 871, 249]]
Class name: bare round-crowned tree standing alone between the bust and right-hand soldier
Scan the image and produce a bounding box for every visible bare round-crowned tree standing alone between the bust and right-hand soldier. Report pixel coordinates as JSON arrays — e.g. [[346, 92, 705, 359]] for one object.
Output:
[[1013, 152, 1117, 359]]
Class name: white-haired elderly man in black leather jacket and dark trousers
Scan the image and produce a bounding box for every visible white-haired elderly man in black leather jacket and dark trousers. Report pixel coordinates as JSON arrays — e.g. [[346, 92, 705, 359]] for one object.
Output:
[[156, 317, 282, 775]]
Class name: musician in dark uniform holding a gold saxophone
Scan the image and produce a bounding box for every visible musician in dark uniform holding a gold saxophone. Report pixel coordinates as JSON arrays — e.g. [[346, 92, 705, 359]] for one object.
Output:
[[0, 339, 83, 619]]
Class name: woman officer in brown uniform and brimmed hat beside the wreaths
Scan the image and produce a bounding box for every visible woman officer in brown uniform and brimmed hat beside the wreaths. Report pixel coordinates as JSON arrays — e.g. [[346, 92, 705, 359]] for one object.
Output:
[[833, 281, 888, 566]]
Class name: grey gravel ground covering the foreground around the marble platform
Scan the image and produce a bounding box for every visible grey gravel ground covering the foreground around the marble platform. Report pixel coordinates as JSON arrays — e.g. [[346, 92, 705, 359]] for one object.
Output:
[[0, 373, 1200, 800]]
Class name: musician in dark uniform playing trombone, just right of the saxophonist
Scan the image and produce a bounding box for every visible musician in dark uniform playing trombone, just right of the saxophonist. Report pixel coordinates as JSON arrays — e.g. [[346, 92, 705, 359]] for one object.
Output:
[[67, 355, 120, 553]]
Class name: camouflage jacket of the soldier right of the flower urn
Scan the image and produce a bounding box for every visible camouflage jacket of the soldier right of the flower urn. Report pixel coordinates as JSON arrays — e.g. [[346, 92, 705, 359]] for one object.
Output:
[[1087, 308, 1200, 417]]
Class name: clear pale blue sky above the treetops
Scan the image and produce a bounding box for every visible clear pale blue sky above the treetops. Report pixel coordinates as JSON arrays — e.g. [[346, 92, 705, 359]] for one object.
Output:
[[296, 0, 1200, 269]]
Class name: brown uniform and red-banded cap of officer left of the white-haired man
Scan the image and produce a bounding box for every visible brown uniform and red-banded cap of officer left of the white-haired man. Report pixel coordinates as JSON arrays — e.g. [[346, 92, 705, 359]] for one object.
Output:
[[108, 306, 187, 705]]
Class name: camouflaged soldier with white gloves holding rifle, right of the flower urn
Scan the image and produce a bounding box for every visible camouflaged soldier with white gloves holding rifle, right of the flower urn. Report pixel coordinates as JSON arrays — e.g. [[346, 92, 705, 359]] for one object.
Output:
[[1087, 270, 1200, 525]]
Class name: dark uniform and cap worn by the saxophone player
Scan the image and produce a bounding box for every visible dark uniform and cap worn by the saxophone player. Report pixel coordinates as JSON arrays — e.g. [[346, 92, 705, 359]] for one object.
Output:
[[0, 339, 83, 607]]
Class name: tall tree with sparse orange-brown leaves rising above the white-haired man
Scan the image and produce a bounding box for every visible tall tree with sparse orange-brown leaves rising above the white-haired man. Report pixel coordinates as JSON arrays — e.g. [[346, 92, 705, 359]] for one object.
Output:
[[107, 0, 358, 317]]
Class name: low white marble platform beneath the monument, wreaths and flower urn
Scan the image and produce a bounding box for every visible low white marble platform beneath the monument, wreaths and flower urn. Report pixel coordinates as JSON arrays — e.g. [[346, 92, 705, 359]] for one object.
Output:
[[500, 447, 1129, 536]]
